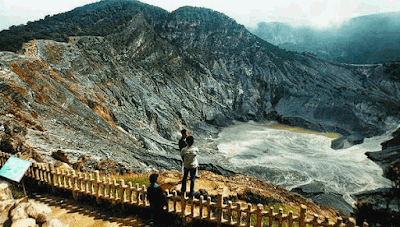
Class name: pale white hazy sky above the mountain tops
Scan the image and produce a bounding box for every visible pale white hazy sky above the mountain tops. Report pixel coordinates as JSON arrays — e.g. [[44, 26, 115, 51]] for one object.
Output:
[[0, 0, 400, 30]]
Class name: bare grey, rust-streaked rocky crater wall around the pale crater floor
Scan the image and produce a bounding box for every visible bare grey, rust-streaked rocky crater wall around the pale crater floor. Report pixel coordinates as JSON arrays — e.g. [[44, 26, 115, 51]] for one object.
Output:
[[0, 1, 400, 213]]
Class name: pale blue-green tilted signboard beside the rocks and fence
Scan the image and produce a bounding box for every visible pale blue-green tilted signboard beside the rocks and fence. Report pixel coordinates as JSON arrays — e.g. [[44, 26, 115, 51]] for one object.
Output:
[[0, 157, 32, 182]]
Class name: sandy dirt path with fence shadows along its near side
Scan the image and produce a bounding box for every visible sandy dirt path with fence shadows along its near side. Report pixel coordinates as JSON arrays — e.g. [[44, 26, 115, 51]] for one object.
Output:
[[32, 195, 150, 227]]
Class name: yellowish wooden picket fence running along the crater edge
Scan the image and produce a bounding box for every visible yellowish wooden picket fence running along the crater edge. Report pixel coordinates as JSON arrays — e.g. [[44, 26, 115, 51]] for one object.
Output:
[[0, 151, 368, 227]]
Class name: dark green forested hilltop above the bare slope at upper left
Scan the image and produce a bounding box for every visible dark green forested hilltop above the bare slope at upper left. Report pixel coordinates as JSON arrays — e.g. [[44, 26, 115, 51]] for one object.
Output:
[[0, 0, 167, 52]]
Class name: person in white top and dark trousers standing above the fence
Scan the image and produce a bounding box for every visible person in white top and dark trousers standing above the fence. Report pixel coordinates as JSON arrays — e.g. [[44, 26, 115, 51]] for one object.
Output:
[[181, 136, 199, 198]]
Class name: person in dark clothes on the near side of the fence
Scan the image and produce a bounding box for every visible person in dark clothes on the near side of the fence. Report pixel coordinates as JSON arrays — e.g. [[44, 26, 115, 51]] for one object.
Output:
[[147, 173, 167, 222]]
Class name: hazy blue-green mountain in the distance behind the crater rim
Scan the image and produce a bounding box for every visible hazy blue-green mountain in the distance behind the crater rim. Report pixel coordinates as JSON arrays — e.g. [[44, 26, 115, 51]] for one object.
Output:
[[250, 12, 400, 64]]
